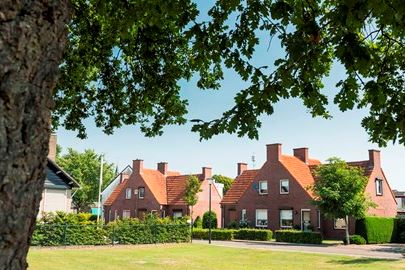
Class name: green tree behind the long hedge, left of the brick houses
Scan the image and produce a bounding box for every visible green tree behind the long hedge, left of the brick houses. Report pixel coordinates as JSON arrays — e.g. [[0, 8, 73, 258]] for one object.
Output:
[[56, 147, 115, 212]]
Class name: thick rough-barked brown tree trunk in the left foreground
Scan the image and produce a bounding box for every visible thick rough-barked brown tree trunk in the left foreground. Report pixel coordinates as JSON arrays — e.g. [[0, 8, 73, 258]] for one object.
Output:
[[0, 0, 69, 270]]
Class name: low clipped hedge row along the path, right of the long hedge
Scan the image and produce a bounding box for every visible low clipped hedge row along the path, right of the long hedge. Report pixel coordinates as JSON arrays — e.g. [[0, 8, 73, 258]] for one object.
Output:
[[193, 229, 273, 241]]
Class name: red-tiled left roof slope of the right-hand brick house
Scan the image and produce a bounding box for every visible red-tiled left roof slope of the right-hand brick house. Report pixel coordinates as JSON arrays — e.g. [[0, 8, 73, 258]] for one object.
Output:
[[221, 170, 259, 204]]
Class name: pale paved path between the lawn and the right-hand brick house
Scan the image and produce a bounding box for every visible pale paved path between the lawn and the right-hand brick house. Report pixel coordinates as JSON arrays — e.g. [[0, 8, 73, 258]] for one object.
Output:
[[193, 240, 405, 259]]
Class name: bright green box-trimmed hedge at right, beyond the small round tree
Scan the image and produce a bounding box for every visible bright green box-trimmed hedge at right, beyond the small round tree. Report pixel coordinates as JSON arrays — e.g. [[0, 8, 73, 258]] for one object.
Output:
[[356, 217, 397, 244]]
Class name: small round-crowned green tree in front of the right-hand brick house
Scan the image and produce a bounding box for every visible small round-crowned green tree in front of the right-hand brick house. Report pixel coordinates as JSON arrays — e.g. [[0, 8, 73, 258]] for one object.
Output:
[[312, 157, 374, 244]]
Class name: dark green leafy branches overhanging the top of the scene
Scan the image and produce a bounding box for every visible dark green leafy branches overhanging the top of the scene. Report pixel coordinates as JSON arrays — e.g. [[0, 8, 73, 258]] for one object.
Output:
[[54, 0, 405, 145]]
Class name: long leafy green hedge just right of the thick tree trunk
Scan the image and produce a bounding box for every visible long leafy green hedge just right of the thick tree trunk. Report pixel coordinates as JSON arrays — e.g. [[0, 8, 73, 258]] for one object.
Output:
[[31, 213, 190, 246]]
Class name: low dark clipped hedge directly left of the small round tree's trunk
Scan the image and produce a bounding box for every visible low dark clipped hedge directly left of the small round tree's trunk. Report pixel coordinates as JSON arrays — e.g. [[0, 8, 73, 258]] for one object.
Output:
[[274, 230, 322, 244]]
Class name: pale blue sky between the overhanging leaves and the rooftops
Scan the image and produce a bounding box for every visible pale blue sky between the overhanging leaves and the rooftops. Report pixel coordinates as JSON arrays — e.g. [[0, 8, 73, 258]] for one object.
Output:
[[57, 1, 405, 190]]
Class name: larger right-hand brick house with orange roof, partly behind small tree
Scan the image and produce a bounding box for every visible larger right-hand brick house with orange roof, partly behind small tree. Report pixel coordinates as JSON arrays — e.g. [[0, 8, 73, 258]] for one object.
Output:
[[221, 144, 396, 238]]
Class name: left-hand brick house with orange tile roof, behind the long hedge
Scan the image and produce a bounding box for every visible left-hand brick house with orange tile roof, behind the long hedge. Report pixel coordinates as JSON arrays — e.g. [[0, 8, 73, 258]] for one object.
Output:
[[104, 159, 222, 226]]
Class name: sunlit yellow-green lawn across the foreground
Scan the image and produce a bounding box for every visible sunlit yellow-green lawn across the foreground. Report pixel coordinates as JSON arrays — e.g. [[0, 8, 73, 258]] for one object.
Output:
[[28, 244, 405, 270]]
